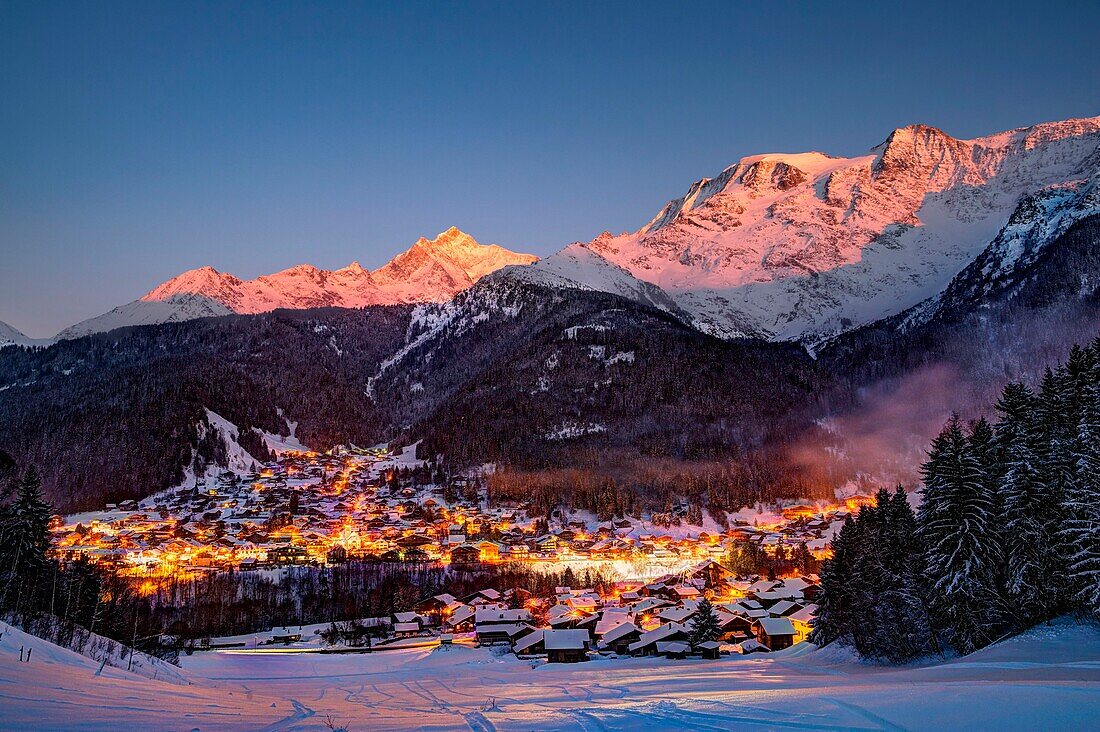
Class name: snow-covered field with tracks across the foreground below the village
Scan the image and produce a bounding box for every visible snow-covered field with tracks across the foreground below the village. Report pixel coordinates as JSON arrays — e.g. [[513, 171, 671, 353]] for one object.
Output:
[[0, 621, 1100, 732]]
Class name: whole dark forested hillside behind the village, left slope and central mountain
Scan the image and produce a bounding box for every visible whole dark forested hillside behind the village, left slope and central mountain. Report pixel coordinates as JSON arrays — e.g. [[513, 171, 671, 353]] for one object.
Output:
[[0, 283, 844, 511]]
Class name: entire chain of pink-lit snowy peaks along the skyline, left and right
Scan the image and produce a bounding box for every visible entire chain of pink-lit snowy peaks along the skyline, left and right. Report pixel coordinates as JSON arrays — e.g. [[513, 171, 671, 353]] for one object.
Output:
[[47, 117, 1100, 345]]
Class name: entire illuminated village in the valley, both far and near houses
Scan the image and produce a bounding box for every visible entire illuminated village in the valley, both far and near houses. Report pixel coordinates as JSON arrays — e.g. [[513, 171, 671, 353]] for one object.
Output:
[[45, 448, 866, 660]]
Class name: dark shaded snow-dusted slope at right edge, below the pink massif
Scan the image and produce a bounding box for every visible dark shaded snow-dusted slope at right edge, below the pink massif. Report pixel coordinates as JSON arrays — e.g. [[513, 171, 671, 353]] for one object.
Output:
[[817, 202, 1100, 394]]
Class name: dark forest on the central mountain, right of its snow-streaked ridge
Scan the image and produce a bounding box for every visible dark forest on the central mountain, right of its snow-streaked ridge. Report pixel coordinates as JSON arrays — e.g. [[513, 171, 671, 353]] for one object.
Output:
[[413, 296, 848, 470]]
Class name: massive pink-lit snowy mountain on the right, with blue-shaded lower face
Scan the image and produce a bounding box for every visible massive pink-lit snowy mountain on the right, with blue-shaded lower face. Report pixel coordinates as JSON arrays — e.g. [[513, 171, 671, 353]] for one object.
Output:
[[535, 117, 1100, 345]]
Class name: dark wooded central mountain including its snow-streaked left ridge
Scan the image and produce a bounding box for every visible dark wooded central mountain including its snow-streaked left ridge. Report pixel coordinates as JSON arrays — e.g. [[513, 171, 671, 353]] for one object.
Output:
[[360, 272, 838, 467]]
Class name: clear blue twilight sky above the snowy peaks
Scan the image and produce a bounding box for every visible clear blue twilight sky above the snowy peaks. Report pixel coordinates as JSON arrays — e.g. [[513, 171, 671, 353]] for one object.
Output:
[[0, 0, 1100, 336]]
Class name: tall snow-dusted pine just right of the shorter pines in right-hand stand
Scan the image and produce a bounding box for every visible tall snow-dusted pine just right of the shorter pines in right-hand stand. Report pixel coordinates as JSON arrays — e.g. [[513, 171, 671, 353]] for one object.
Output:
[[919, 416, 1004, 653]]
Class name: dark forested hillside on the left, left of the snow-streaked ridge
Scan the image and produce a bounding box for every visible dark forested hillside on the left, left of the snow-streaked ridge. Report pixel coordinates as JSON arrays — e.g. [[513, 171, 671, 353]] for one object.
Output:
[[0, 306, 410, 510]]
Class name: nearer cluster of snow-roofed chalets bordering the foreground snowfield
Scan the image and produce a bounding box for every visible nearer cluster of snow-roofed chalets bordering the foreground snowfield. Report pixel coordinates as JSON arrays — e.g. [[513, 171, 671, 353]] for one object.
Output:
[[394, 559, 818, 663]]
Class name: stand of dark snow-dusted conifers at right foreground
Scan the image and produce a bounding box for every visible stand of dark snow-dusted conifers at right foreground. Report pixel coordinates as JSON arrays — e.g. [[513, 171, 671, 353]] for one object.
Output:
[[812, 340, 1100, 662]]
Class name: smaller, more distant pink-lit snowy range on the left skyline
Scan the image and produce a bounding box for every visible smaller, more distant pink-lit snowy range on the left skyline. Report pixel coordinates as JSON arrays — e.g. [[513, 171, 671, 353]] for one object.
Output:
[[58, 227, 537, 339]]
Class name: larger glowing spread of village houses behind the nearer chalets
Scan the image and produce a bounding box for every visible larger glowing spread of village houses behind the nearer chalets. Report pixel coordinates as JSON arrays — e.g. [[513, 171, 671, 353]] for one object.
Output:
[[52, 449, 850, 581]]
